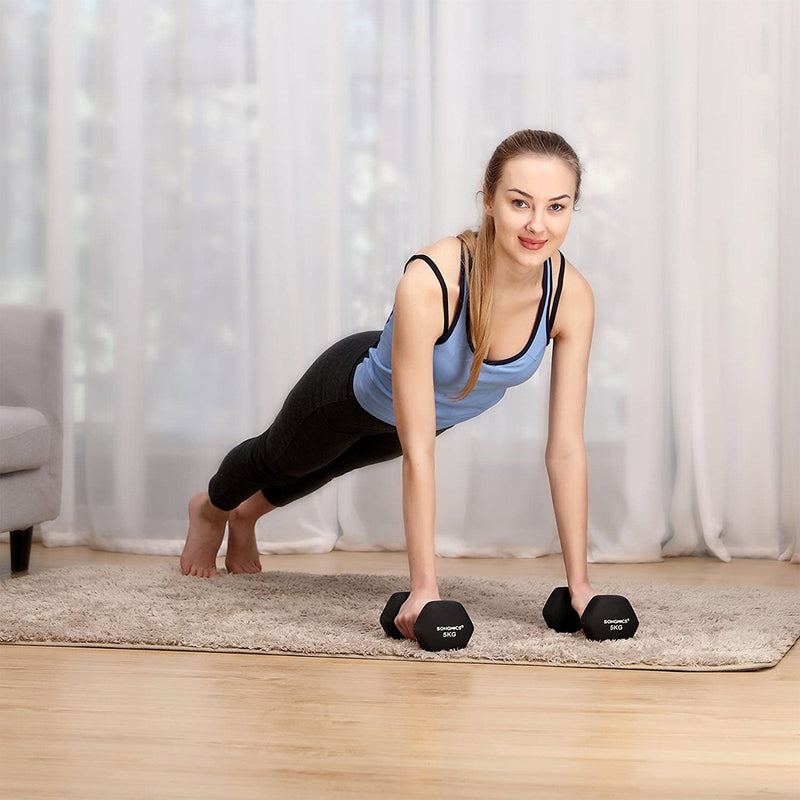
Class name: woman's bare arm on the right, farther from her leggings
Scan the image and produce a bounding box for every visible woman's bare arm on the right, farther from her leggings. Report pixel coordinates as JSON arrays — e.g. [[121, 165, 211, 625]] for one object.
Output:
[[545, 265, 594, 613]]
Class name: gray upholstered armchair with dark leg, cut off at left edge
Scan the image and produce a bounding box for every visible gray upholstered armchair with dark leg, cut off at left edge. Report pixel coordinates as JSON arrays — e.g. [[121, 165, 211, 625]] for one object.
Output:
[[0, 305, 64, 572]]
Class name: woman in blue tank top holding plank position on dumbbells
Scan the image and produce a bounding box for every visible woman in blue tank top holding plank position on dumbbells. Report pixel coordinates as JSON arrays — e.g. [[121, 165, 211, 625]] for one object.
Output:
[[181, 130, 595, 639]]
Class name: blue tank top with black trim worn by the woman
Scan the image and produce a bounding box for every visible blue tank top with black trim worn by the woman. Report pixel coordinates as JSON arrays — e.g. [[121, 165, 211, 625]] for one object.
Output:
[[353, 241, 564, 430]]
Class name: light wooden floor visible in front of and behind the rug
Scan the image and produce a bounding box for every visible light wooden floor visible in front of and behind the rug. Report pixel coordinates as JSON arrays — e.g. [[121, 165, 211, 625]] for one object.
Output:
[[0, 544, 800, 800]]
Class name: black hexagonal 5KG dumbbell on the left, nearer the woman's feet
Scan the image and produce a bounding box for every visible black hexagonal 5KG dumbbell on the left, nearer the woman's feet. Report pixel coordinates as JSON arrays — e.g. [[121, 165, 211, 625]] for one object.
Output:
[[381, 592, 475, 651]]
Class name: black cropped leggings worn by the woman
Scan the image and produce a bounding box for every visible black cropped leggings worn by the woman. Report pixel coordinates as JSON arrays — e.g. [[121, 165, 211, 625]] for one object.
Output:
[[208, 331, 447, 511]]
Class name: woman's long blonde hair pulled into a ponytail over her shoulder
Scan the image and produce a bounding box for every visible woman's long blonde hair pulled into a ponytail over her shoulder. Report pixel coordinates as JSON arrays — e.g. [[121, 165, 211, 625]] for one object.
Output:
[[456, 129, 583, 400]]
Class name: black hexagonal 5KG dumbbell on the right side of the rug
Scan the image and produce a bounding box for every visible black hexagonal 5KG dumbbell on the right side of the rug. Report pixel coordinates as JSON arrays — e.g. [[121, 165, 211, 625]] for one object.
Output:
[[542, 586, 639, 641]]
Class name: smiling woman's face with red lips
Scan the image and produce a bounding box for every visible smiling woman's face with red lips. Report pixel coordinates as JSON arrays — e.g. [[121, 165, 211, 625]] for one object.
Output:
[[484, 155, 575, 267]]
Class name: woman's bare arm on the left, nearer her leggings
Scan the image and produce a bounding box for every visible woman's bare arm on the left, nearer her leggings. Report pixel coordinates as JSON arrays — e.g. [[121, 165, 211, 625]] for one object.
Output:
[[392, 261, 442, 639]]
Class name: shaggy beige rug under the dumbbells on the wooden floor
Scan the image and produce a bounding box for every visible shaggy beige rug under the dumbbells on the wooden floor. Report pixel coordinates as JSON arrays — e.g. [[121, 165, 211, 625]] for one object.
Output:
[[0, 564, 800, 671]]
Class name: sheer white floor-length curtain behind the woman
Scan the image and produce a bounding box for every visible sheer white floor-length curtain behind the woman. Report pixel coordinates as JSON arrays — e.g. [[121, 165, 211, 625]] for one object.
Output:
[[0, 0, 800, 562]]
